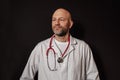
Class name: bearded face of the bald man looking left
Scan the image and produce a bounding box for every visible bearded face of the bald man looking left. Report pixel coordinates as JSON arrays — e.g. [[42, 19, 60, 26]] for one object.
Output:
[[52, 10, 71, 36]]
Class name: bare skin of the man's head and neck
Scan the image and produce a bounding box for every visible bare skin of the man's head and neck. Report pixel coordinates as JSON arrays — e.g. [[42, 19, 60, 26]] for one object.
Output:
[[52, 8, 73, 42]]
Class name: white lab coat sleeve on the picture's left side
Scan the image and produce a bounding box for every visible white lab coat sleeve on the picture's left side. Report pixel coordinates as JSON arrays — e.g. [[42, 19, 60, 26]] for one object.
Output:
[[20, 44, 39, 80]]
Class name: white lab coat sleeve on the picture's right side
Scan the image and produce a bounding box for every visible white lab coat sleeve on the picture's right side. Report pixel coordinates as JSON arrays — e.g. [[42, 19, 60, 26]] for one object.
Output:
[[85, 45, 100, 80]]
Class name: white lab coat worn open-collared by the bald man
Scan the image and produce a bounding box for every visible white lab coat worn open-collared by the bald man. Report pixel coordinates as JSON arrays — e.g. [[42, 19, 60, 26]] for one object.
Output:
[[20, 36, 100, 80]]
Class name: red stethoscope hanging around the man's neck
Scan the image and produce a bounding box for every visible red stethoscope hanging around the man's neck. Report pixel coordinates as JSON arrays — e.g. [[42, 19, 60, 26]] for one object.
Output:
[[46, 35, 70, 71]]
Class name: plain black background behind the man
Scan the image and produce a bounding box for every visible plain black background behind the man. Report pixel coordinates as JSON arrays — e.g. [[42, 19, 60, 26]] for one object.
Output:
[[0, 0, 120, 80]]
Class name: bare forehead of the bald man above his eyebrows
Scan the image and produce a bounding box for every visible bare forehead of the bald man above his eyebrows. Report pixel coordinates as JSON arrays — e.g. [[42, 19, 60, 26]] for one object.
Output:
[[52, 9, 70, 18]]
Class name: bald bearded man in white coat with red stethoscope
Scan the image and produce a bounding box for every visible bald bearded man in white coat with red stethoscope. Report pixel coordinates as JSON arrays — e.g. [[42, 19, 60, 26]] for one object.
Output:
[[20, 8, 100, 80]]
